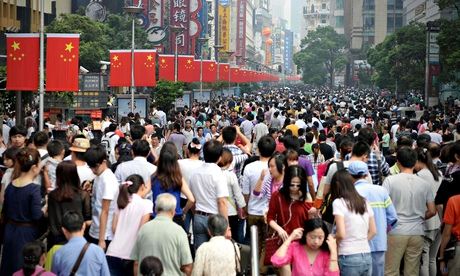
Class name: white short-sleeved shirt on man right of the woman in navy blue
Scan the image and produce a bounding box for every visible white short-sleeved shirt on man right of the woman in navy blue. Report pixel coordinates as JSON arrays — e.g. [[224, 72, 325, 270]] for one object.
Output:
[[189, 163, 228, 214]]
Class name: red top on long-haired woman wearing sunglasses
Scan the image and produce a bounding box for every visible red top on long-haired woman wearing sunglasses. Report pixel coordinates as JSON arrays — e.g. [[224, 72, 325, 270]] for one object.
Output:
[[267, 191, 312, 235]]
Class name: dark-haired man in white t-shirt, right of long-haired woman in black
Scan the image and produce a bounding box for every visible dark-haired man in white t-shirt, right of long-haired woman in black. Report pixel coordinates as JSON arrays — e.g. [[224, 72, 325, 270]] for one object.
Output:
[[85, 145, 119, 250]]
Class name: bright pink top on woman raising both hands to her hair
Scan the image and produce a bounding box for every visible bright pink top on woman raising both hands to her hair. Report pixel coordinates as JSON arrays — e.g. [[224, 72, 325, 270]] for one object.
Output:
[[271, 241, 340, 276]]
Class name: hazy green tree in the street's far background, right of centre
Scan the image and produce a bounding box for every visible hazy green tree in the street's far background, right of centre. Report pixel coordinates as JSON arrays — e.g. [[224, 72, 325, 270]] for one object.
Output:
[[294, 26, 347, 87]]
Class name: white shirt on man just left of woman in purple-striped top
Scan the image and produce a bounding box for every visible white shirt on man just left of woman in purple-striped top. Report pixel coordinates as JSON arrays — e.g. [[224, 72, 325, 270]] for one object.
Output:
[[242, 161, 268, 216]]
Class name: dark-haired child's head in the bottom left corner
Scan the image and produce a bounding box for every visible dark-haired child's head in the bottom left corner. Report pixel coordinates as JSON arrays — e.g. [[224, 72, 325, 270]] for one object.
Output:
[[13, 241, 56, 276]]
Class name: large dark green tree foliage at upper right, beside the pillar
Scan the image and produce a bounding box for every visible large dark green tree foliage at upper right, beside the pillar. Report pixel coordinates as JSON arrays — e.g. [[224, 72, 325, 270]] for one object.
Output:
[[367, 24, 426, 92]]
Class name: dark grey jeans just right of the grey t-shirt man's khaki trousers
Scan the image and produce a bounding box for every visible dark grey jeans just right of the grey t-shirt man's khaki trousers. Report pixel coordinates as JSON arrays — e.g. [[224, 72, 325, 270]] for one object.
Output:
[[420, 229, 441, 276]]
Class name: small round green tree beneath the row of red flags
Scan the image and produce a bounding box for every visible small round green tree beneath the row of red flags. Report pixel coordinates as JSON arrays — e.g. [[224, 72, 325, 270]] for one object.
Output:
[[151, 80, 184, 111]]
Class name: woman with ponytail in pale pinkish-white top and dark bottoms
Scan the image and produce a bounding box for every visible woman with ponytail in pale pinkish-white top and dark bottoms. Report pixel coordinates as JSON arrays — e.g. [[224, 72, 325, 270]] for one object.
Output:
[[107, 174, 153, 276]]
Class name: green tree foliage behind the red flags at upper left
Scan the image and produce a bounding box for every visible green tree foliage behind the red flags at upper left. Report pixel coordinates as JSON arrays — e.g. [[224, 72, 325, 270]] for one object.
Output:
[[46, 14, 148, 72]]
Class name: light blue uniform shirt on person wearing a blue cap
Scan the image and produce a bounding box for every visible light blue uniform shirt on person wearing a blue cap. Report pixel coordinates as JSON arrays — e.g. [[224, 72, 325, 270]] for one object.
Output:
[[355, 179, 398, 252]]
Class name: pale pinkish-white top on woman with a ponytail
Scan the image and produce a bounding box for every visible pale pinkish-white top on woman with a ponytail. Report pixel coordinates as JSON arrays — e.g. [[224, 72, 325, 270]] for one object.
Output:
[[107, 194, 153, 260]]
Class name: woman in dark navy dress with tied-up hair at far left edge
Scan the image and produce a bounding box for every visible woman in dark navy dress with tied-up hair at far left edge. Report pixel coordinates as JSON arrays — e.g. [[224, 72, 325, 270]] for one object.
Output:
[[0, 148, 47, 275]]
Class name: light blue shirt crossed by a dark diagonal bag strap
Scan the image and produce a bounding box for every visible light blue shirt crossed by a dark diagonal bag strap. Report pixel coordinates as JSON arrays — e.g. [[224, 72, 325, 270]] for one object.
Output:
[[51, 237, 110, 276]]
